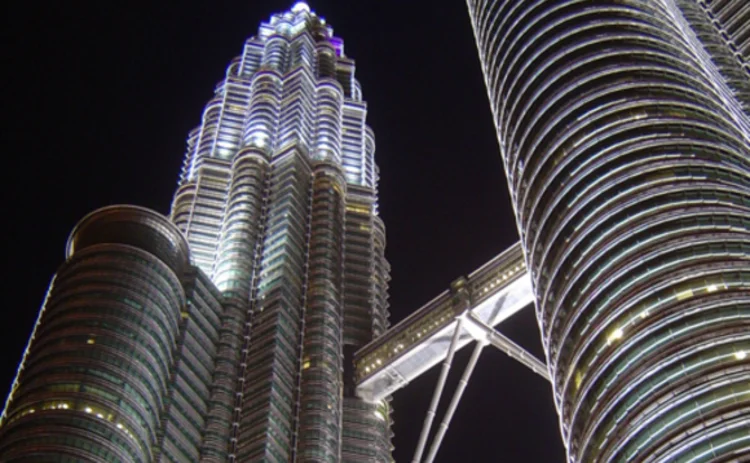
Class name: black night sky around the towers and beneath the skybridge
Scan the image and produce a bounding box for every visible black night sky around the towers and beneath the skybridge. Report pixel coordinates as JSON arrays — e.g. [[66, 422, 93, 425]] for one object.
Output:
[[0, 0, 564, 463]]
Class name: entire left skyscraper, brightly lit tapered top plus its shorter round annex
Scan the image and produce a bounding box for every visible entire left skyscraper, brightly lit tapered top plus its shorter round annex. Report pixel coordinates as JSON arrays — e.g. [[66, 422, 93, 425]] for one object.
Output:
[[0, 2, 391, 462]]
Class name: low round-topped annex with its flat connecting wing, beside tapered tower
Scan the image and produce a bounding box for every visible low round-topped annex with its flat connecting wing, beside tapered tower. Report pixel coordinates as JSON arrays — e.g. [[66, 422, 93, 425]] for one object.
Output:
[[0, 206, 228, 462]]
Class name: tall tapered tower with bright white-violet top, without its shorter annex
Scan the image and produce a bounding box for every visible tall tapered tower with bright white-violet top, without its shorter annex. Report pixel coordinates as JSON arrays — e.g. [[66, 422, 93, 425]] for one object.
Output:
[[171, 3, 390, 461]]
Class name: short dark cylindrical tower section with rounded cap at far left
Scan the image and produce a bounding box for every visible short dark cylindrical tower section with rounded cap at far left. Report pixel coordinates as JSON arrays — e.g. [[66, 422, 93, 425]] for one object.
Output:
[[0, 206, 189, 462]]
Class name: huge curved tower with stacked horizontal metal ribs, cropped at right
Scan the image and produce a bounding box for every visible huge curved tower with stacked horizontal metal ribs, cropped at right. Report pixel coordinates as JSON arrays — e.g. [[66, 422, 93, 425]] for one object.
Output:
[[467, 0, 750, 462]]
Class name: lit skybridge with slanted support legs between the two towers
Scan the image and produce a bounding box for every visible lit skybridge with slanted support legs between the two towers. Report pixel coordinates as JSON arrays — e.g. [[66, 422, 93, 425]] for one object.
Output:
[[354, 243, 549, 463]]
